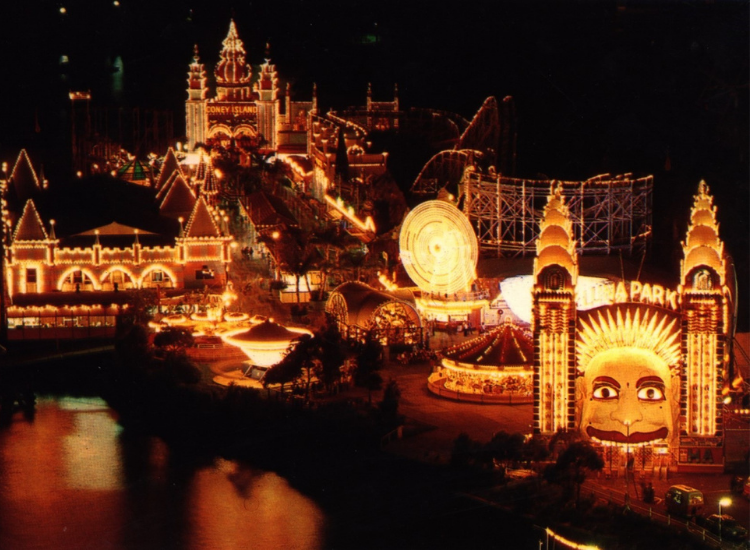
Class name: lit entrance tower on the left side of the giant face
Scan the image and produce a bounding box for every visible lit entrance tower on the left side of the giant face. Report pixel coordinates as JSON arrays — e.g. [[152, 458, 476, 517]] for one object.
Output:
[[532, 186, 578, 435]]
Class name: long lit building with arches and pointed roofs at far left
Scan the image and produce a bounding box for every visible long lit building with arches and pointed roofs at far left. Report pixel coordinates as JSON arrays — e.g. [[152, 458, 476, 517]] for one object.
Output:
[[2, 151, 232, 340]]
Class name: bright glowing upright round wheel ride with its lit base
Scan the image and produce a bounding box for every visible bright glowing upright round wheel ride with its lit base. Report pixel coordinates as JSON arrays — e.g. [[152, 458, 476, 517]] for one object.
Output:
[[399, 200, 488, 326]]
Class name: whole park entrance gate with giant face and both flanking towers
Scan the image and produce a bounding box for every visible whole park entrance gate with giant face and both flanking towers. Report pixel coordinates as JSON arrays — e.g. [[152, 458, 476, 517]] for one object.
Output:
[[532, 182, 738, 471]]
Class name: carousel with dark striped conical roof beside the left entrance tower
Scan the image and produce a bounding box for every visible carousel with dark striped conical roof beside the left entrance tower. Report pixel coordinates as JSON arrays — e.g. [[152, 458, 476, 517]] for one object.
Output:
[[427, 320, 534, 405]]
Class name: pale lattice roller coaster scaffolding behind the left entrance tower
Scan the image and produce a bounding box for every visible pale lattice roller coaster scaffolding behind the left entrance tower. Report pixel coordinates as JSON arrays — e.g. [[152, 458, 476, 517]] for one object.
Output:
[[459, 172, 653, 257]]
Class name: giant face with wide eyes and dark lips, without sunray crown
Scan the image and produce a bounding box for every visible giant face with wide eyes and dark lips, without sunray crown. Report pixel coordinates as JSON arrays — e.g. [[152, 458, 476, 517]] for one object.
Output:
[[579, 348, 680, 445]]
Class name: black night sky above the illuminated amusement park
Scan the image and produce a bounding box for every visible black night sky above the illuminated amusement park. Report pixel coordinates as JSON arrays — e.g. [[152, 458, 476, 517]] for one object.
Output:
[[0, 0, 750, 326]]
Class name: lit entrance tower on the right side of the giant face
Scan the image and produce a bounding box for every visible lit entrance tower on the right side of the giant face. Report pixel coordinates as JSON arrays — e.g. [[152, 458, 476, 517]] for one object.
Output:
[[678, 181, 733, 444]]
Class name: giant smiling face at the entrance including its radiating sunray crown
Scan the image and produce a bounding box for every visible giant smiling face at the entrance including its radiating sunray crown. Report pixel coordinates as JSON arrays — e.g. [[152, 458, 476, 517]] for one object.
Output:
[[576, 304, 681, 446]]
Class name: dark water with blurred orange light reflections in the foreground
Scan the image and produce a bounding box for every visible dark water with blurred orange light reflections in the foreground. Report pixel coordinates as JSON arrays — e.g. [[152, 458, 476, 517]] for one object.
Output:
[[0, 397, 325, 550]]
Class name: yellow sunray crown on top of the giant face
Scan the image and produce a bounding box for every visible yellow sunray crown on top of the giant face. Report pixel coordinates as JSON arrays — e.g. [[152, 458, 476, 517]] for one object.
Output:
[[576, 307, 682, 371]]
